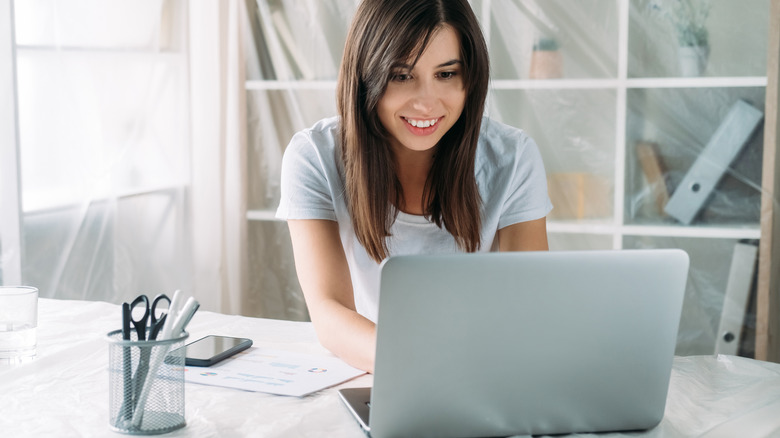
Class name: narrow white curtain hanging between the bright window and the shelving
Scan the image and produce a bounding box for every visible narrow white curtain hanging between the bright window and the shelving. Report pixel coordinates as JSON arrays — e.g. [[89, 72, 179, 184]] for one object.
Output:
[[189, 0, 247, 314]]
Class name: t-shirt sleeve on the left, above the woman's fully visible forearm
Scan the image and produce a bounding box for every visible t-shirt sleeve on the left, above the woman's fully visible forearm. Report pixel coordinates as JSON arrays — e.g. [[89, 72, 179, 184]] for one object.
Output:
[[276, 131, 336, 221]]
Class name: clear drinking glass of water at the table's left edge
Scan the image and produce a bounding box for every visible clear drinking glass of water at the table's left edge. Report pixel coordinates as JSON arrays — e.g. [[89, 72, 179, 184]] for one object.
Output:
[[0, 286, 38, 365]]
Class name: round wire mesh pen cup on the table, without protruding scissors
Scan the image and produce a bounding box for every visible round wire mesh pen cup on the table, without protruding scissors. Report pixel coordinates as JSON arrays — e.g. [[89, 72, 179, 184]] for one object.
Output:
[[107, 330, 189, 435]]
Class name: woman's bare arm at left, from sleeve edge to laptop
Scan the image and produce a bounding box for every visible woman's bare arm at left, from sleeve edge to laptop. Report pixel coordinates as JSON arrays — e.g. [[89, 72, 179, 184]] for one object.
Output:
[[287, 220, 376, 373]]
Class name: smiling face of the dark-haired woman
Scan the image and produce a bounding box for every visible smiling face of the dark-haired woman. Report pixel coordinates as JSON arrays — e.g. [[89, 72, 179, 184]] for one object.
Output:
[[378, 25, 466, 155]]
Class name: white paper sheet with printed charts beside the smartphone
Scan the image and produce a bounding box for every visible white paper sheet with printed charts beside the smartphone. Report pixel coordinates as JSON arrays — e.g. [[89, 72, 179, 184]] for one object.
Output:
[[184, 347, 365, 397]]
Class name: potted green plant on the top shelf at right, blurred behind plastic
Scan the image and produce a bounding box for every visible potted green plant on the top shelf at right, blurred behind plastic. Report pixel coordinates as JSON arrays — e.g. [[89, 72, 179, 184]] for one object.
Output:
[[650, 0, 711, 76]]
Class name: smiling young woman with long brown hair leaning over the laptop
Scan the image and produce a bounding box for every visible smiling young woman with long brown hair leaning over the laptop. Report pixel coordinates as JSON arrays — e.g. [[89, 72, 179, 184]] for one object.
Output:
[[277, 0, 552, 372]]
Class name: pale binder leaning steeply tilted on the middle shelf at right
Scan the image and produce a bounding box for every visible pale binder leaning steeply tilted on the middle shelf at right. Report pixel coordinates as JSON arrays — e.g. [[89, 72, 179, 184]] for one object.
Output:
[[664, 100, 764, 224]]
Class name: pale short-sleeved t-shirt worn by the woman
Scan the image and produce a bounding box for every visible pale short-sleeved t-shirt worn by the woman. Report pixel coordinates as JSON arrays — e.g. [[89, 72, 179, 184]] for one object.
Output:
[[276, 117, 552, 321]]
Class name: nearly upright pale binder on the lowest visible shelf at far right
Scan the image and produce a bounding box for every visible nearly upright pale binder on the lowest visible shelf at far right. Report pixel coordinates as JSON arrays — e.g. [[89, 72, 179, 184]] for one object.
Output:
[[715, 242, 758, 355]]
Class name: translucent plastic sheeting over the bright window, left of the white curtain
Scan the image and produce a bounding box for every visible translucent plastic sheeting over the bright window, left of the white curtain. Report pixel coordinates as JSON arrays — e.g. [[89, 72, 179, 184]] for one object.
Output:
[[8, 0, 191, 302]]
